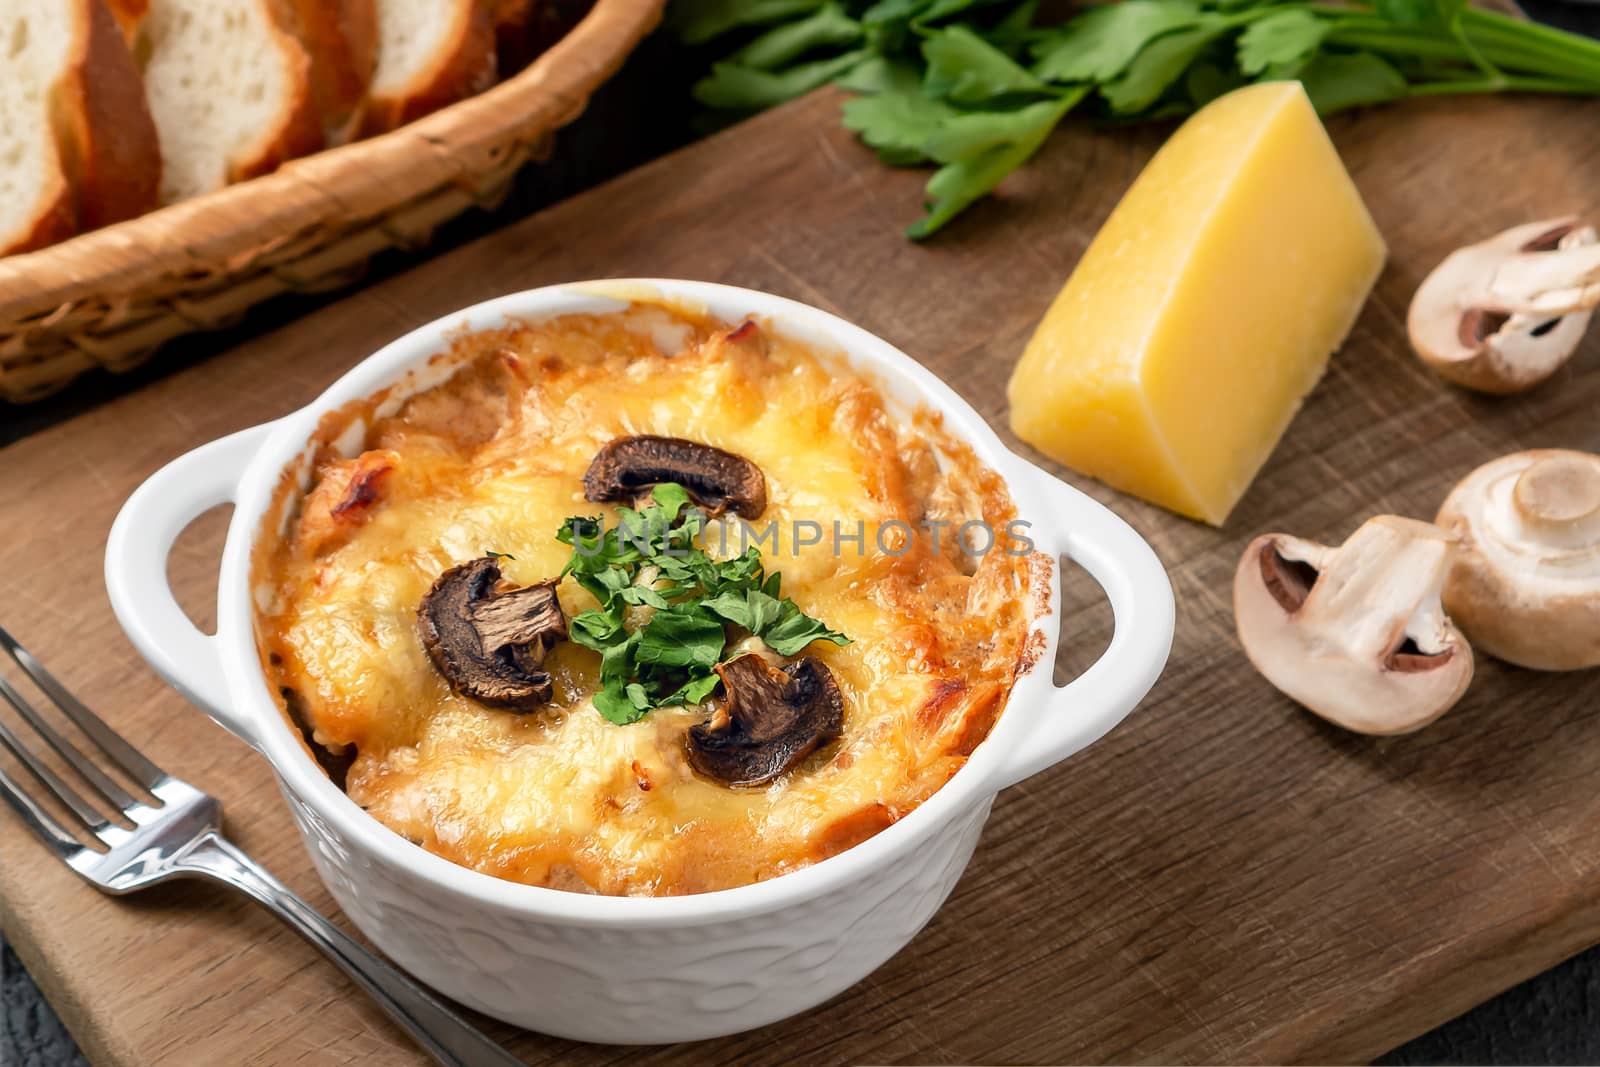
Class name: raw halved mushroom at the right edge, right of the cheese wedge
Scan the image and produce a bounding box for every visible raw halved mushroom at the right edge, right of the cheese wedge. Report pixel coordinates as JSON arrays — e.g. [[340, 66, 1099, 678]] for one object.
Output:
[[1406, 218, 1600, 394]]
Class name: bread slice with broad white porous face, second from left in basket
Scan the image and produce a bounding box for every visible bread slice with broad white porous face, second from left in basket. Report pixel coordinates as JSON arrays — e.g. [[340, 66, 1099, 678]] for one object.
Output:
[[134, 0, 323, 203]]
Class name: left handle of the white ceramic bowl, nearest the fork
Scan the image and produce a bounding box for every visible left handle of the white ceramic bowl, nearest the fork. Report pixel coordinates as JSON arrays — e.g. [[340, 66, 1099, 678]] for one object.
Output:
[[106, 424, 272, 745]]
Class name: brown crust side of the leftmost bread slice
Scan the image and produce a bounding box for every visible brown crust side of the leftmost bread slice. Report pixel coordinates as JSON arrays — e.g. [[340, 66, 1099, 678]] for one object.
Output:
[[53, 0, 162, 232]]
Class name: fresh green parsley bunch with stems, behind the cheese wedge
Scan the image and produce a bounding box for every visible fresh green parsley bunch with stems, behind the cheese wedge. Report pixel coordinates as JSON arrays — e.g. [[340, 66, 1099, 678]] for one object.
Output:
[[674, 0, 1600, 238]]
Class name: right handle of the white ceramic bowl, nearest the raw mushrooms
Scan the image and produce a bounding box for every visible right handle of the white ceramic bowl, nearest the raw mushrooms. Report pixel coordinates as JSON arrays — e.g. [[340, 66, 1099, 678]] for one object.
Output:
[[995, 469, 1174, 789]]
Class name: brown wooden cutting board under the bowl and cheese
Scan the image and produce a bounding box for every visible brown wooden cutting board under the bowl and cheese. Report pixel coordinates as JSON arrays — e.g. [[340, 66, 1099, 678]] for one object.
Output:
[[0, 85, 1600, 1067]]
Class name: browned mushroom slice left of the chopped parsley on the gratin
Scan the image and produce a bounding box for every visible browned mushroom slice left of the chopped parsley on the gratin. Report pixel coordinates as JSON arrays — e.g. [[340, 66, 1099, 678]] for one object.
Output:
[[416, 558, 566, 712]]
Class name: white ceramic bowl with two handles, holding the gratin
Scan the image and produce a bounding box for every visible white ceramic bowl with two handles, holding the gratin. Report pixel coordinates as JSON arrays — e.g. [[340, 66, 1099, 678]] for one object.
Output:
[[106, 280, 1173, 1043]]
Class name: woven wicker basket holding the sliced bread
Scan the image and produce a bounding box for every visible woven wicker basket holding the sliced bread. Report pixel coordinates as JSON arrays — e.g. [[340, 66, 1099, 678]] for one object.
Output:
[[0, 0, 666, 403]]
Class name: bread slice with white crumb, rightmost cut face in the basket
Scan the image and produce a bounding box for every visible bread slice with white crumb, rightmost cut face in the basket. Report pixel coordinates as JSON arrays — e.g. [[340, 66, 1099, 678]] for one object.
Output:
[[362, 0, 496, 133]]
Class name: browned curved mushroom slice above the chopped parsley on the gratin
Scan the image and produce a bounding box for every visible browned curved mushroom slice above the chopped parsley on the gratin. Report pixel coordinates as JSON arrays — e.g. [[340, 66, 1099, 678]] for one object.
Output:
[[584, 434, 766, 518]]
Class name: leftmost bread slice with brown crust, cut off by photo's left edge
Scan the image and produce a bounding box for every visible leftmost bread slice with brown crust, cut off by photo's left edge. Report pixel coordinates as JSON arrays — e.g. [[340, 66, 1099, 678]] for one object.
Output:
[[0, 0, 160, 254]]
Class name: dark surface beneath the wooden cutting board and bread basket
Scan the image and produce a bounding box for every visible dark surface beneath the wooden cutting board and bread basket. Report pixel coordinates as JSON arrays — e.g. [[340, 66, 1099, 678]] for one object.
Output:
[[9, 0, 1600, 1067]]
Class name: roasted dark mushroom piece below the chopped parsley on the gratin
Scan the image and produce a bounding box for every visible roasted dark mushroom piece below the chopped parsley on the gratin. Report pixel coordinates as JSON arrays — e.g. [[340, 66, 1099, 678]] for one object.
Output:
[[688, 653, 845, 785]]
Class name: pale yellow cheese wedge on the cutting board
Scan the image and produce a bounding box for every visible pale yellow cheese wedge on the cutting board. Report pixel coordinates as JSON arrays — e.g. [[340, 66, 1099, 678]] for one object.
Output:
[[1008, 82, 1384, 525]]
